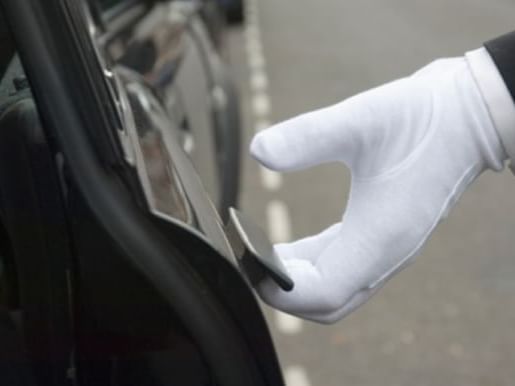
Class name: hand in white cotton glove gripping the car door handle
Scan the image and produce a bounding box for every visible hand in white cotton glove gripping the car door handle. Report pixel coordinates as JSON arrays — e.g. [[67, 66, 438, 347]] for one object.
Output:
[[251, 58, 507, 323]]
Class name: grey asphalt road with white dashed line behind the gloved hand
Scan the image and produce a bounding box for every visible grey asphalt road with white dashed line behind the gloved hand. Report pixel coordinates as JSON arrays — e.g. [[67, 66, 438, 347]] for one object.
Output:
[[229, 0, 515, 386]]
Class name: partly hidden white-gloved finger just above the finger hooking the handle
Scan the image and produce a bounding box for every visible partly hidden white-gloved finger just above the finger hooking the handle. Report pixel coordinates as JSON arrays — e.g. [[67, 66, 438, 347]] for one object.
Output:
[[274, 223, 341, 264]]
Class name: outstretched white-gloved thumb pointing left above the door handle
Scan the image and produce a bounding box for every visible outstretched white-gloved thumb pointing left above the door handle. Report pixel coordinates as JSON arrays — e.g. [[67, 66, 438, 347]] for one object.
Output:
[[250, 98, 370, 171]]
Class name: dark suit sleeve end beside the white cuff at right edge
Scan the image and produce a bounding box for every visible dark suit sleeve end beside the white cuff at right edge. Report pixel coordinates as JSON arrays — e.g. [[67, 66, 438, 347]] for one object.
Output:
[[485, 31, 515, 101]]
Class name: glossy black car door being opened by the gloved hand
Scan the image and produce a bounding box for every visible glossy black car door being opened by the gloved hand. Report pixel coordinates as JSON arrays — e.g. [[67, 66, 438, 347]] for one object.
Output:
[[0, 0, 283, 386]]
